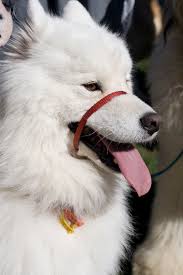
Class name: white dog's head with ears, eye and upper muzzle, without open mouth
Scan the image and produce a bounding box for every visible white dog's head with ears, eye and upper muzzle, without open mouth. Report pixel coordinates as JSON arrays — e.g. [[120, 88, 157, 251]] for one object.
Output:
[[2, 0, 158, 147]]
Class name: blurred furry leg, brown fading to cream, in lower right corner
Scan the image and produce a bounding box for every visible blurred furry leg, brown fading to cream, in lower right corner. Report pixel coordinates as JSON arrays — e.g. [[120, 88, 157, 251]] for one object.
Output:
[[133, 157, 183, 275]]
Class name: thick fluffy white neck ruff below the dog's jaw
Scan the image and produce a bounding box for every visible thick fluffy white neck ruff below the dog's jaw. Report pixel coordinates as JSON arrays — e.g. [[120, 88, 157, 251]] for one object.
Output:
[[0, 111, 116, 216]]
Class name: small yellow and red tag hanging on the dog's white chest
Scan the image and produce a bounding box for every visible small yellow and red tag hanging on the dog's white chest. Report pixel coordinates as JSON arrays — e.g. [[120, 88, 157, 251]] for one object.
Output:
[[59, 208, 84, 234]]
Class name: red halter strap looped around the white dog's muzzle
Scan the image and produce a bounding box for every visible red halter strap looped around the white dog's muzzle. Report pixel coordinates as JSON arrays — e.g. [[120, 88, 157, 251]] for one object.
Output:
[[73, 91, 126, 151]]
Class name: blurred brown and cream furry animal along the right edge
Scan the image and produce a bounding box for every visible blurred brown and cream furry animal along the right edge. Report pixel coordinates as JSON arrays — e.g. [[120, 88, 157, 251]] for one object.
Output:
[[134, 0, 183, 275]]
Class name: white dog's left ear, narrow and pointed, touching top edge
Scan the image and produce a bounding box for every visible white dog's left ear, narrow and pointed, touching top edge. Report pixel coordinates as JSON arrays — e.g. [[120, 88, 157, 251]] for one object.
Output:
[[28, 0, 47, 29]]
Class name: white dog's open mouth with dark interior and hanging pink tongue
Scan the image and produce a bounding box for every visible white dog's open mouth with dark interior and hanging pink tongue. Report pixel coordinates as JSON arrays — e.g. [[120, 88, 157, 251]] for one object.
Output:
[[69, 122, 151, 196]]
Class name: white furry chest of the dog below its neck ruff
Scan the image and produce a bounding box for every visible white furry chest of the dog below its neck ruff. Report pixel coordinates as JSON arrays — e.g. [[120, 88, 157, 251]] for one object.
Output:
[[0, 188, 129, 275]]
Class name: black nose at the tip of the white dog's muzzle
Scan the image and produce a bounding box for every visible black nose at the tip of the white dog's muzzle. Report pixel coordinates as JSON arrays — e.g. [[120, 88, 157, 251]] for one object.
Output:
[[140, 113, 160, 135]]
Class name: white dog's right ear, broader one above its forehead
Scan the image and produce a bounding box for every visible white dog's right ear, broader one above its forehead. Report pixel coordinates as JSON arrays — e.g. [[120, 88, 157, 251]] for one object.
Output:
[[63, 0, 94, 25]]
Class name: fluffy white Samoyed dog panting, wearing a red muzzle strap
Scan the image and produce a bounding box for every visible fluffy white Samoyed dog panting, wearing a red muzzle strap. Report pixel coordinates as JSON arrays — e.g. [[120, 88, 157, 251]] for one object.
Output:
[[0, 0, 159, 275]]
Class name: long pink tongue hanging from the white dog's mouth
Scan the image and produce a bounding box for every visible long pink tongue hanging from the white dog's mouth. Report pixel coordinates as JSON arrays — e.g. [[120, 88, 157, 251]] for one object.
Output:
[[109, 146, 152, 197]]
